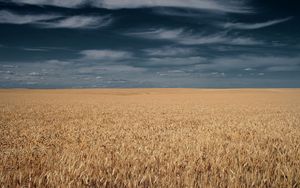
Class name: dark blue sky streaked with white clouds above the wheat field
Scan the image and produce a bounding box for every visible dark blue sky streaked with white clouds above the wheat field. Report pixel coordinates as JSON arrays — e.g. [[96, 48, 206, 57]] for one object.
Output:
[[0, 0, 300, 88]]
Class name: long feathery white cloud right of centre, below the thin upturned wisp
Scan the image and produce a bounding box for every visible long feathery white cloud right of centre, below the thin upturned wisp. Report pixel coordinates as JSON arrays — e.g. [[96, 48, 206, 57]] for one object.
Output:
[[128, 29, 263, 45]]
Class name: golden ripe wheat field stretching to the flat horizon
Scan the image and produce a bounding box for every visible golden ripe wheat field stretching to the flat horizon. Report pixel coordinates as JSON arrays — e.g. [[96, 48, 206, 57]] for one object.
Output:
[[0, 89, 300, 187]]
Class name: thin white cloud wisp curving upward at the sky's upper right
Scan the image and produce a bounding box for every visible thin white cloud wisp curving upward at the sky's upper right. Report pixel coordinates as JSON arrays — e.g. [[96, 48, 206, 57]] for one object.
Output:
[[222, 17, 292, 30]]
